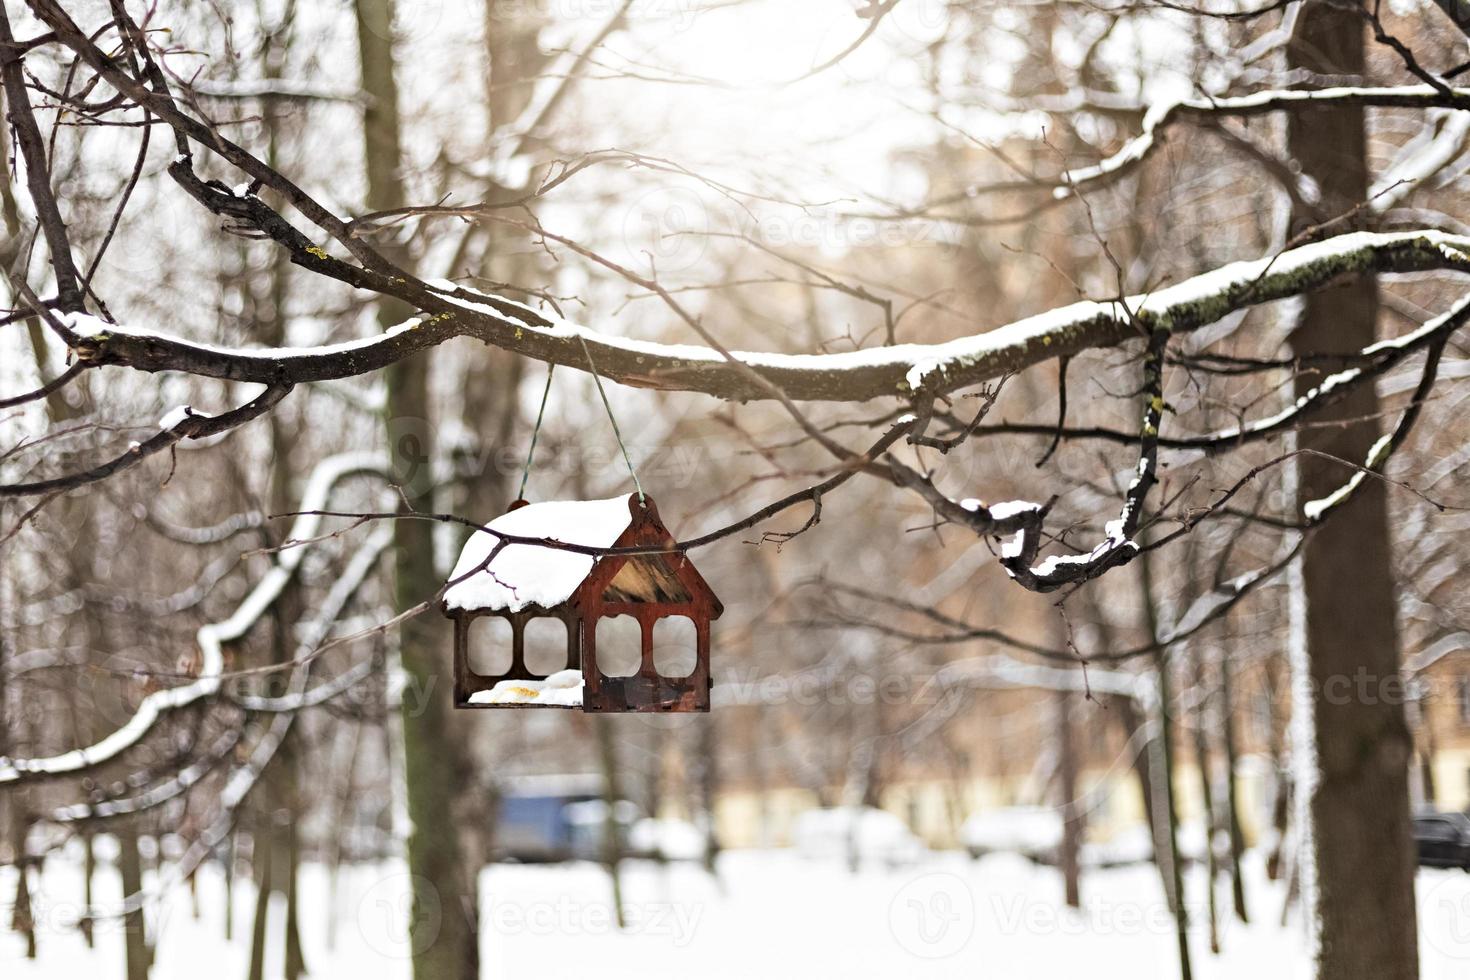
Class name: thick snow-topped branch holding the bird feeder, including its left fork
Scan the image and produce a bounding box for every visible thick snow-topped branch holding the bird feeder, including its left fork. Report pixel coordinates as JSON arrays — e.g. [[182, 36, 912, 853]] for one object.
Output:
[[66, 231, 1470, 401]]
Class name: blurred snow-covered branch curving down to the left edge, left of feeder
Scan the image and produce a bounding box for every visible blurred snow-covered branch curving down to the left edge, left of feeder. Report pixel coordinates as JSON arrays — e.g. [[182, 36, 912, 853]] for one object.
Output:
[[0, 453, 387, 783]]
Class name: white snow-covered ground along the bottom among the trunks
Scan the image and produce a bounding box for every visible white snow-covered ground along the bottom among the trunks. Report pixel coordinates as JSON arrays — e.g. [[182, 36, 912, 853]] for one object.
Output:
[[0, 851, 1470, 980]]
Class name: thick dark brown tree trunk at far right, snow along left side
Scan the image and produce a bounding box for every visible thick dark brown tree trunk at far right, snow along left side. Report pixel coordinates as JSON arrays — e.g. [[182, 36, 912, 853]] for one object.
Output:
[[1288, 0, 1419, 980]]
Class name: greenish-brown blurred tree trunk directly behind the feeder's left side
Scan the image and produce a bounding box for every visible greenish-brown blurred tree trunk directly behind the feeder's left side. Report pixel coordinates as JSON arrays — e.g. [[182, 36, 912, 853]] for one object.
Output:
[[356, 0, 479, 980]]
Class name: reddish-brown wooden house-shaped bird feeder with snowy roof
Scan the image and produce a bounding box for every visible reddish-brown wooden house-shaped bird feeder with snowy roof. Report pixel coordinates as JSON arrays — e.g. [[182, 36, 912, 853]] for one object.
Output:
[[442, 494, 723, 711]]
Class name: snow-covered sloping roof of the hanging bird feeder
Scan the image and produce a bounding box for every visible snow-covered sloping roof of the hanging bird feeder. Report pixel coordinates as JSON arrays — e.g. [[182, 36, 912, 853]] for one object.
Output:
[[444, 495, 638, 613]]
